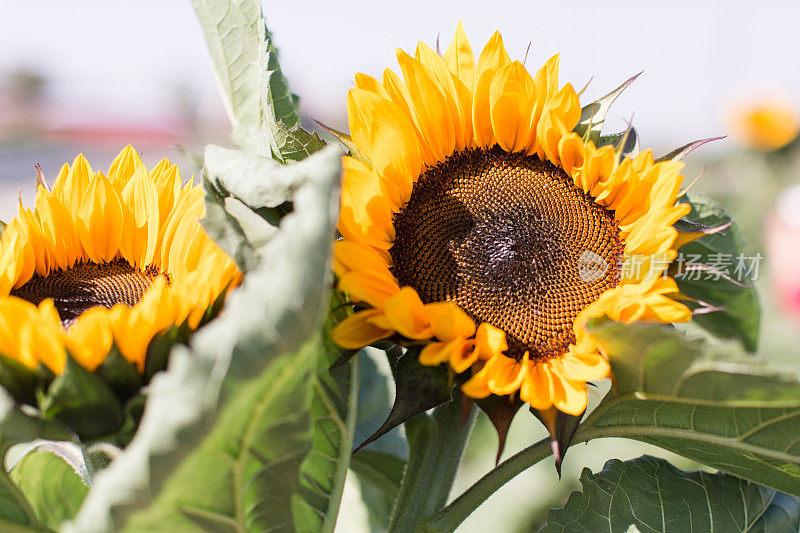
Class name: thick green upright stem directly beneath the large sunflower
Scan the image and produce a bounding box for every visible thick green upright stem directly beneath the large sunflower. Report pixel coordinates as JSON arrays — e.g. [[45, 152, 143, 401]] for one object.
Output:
[[389, 398, 475, 533]]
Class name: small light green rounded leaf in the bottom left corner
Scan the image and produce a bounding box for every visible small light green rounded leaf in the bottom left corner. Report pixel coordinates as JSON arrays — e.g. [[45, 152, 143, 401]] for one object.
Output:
[[11, 450, 89, 529]]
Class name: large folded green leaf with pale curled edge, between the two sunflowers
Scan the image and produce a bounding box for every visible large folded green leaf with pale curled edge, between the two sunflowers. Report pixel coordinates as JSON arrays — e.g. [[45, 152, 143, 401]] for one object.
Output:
[[65, 148, 346, 532]]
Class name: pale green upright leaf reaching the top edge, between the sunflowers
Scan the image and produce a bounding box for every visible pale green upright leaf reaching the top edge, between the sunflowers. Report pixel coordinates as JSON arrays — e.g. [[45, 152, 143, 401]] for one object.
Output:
[[192, 0, 325, 162]]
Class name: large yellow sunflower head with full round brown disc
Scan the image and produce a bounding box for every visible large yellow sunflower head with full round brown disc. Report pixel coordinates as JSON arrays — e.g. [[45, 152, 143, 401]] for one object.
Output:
[[333, 24, 691, 415]]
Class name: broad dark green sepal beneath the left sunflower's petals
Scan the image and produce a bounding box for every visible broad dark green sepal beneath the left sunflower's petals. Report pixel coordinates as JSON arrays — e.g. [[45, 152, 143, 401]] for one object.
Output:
[[39, 354, 123, 440]]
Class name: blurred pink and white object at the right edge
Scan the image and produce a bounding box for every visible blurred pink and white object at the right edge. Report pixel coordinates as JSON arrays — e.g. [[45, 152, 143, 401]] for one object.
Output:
[[766, 184, 800, 317]]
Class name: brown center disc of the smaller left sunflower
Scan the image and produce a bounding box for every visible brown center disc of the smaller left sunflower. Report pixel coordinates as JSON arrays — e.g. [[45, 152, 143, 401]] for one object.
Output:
[[11, 260, 159, 328]]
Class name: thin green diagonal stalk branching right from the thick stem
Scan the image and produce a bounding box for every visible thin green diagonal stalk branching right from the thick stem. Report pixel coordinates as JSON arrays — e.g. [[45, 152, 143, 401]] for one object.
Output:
[[416, 437, 553, 533]]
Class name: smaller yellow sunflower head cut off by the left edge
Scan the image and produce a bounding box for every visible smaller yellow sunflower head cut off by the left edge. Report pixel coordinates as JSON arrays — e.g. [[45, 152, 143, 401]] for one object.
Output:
[[0, 146, 240, 375]]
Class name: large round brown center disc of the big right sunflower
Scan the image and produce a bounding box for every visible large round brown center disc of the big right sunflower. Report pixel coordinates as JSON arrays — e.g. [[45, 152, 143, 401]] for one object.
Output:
[[389, 147, 624, 360]]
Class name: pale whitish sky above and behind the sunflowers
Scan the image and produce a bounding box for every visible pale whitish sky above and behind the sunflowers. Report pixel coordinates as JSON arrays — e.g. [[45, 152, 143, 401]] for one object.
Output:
[[0, 0, 800, 154]]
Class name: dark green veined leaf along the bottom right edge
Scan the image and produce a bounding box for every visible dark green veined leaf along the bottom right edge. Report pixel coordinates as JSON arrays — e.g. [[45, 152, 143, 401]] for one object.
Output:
[[541, 456, 800, 533]]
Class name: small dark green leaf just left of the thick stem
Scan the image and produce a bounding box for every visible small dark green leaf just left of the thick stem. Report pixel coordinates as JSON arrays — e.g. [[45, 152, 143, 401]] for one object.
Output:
[[350, 450, 406, 531]]
